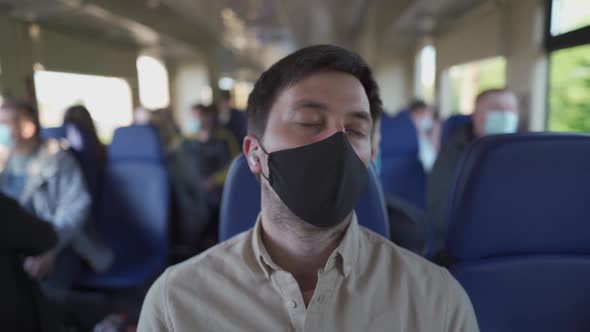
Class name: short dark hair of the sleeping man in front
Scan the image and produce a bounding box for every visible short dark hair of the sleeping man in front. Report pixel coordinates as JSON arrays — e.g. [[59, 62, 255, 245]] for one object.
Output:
[[246, 45, 383, 138]]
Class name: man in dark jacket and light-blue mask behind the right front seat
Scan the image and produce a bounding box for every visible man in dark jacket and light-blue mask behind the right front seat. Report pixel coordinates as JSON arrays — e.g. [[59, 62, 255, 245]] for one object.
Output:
[[427, 89, 518, 263]]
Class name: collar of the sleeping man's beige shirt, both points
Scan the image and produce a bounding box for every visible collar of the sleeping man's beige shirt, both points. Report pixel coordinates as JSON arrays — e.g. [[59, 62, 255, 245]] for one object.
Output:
[[252, 212, 360, 279]]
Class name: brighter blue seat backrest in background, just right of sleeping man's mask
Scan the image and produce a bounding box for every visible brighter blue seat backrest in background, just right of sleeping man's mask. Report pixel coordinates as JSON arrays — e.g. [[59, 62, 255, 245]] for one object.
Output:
[[381, 112, 426, 210]]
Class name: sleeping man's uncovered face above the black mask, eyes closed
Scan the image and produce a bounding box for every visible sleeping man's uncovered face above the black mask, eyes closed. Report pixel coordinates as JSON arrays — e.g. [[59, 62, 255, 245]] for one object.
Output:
[[251, 72, 372, 167]]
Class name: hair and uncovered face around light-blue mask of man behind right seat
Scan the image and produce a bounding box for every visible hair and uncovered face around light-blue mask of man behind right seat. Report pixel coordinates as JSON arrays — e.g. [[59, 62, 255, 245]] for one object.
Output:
[[473, 91, 518, 137]]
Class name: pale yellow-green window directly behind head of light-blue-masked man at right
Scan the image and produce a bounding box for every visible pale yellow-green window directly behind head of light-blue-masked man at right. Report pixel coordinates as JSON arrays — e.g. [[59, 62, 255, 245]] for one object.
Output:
[[448, 57, 506, 114]]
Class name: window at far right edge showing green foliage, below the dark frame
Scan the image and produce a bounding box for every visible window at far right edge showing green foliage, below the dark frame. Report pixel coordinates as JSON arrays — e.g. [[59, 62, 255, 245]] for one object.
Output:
[[548, 45, 590, 132]]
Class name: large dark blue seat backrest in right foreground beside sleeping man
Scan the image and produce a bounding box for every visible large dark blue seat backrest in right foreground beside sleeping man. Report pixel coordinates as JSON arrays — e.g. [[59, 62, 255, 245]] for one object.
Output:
[[447, 134, 590, 332]]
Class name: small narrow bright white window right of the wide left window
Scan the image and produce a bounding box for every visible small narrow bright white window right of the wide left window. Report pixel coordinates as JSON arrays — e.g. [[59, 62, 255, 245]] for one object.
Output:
[[137, 55, 170, 109]]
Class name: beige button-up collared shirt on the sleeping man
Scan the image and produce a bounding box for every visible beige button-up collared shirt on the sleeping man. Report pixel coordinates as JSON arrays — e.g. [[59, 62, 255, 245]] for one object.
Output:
[[138, 216, 479, 332]]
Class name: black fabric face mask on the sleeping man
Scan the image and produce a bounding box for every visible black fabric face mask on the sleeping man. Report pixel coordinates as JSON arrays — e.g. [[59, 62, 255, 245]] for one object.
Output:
[[262, 132, 368, 228]]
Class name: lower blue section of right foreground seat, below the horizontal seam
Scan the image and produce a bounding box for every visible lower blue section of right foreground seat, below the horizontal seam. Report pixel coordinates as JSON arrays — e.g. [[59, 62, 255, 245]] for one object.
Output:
[[451, 255, 590, 332]]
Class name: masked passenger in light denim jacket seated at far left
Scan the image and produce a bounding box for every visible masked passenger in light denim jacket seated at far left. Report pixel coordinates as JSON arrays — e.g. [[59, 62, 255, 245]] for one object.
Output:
[[0, 100, 112, 302]]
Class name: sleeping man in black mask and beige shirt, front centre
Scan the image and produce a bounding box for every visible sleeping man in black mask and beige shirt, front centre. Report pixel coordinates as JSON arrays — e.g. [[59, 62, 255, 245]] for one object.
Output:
[[138, 45, 478, 332]]
